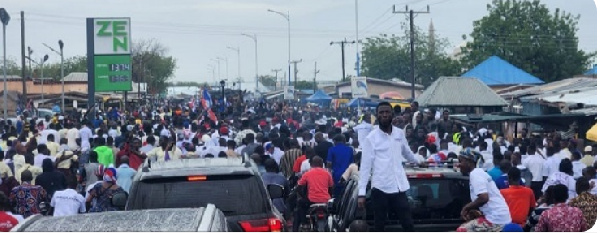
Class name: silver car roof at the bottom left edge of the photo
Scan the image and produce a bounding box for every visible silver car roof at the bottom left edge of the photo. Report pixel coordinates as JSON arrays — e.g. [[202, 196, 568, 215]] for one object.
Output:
[[13, 204, 222, 232]]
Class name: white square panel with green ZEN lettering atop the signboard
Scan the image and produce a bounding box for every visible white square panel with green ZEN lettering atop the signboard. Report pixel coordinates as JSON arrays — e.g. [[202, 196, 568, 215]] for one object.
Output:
[[94, 18, 131, 55]]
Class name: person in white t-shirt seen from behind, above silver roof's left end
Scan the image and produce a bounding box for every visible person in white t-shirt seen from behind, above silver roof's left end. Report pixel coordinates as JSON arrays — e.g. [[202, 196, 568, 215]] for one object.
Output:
[[50, 179, 85, 216]]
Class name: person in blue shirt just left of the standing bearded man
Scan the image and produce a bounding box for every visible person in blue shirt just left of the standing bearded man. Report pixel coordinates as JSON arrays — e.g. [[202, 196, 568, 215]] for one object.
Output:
[[327, 134, 354, 196]]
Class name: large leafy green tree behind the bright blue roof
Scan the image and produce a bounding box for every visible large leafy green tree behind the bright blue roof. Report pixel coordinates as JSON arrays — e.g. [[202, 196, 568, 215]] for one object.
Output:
[[462, 0, 595, 82]]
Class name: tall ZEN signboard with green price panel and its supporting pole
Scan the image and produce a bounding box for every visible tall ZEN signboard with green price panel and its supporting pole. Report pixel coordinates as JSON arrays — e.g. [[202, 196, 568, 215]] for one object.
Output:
[[87, 18, 132, 123]]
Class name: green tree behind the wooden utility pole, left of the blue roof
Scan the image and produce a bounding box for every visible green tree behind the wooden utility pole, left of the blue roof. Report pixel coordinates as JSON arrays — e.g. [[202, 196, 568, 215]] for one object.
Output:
[[362, 25, 460, 86]]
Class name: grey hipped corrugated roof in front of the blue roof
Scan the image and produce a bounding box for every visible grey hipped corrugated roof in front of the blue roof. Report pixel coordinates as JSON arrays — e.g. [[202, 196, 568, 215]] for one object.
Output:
[[416, 77, 508, 107]]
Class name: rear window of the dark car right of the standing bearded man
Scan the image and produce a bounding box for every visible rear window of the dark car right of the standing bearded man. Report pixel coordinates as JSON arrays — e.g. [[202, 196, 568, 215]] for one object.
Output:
[[407, 179, 469, 219]]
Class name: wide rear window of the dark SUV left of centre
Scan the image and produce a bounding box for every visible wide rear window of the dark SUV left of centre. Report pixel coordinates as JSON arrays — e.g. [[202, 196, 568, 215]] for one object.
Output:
[[128, 175, 268, 216]]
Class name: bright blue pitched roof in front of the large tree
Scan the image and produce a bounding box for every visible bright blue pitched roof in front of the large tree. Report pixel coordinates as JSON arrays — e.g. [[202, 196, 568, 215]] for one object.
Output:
[[461, 56, 544, 86]]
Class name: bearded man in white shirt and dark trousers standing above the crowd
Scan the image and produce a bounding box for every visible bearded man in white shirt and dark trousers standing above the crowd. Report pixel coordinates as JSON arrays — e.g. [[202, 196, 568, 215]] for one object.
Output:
[[358, 102, 417, 231]]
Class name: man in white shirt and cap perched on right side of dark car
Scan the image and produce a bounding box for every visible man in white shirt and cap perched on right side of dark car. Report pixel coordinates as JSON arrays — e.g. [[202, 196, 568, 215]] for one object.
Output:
[[457, 148, 512, 232]]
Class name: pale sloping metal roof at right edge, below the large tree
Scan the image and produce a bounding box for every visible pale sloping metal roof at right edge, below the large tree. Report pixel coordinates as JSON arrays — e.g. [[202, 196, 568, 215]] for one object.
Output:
[[502, 77, 598, 98]]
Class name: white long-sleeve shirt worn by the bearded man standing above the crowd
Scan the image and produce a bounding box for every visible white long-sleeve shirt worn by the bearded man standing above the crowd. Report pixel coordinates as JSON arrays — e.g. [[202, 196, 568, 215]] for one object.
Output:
[[358, 127, 418, 196]]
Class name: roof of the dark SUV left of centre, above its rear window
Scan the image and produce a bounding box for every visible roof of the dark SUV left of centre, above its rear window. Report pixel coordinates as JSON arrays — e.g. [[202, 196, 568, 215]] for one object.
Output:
[[136, 158, 259, 180]]
